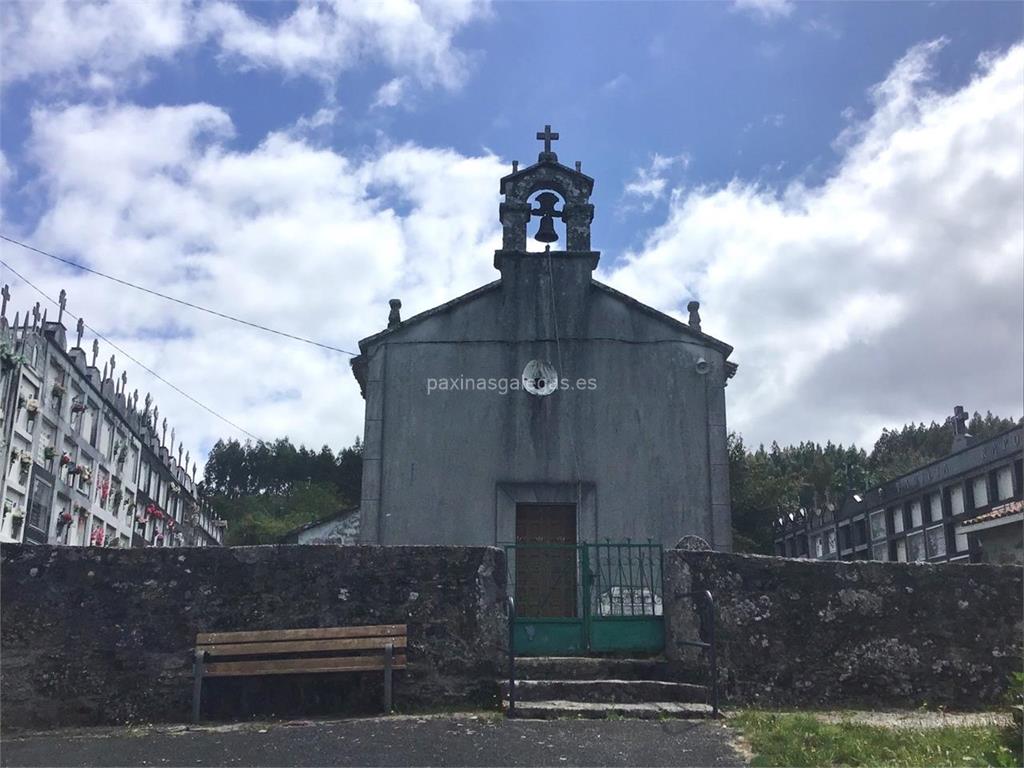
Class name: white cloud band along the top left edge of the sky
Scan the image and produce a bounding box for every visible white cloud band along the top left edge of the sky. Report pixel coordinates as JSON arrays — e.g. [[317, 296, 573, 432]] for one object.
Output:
[[0, 0, 487, 91]]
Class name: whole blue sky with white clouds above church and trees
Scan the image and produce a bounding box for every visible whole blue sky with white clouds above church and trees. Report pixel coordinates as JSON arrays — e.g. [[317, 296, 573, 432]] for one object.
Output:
[[0, 0, 1024, 462]]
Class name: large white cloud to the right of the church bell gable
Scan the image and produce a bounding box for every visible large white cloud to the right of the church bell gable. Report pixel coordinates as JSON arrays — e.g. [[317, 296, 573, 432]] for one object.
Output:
[[607, 41, 1024, 441]]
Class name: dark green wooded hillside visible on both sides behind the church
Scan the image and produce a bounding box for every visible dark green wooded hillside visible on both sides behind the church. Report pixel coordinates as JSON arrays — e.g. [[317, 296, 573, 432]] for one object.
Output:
[[205, 413, 1016, 553]]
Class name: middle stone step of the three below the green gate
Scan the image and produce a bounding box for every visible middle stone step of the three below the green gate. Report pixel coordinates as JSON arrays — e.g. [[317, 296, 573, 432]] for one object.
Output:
[[502, 680, 709, 703]]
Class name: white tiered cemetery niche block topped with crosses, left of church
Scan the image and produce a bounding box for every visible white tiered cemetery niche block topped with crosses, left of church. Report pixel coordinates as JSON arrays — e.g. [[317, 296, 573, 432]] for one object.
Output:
[[0, 286, 225, 547]]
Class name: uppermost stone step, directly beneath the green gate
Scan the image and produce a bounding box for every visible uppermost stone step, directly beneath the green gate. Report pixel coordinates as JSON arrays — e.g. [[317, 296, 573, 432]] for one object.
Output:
[[515, 656, 703, 683]]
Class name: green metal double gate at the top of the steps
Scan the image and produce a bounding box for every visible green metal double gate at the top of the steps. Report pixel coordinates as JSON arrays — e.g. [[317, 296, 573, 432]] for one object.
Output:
[[505, 541, 665, 656]]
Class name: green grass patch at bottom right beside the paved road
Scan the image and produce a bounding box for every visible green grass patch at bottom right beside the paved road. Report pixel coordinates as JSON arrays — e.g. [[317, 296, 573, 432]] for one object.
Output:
[[730, 711, 1024, 768]]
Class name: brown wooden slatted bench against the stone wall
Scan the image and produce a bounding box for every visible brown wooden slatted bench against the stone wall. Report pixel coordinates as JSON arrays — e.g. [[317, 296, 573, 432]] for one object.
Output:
[[193, 624, 407, 723]]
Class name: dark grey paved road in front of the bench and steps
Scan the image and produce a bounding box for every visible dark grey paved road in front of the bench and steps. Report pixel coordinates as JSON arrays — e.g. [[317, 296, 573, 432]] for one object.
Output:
[[0, 715, 743, 766]]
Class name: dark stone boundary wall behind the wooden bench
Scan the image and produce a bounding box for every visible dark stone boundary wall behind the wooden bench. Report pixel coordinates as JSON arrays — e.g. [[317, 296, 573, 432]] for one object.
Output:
[[0, 544, 507, 729]]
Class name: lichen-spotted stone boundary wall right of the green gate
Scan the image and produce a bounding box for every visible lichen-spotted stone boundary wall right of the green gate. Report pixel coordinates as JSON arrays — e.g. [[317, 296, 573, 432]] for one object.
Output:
[[665, 550, 1024, 709]]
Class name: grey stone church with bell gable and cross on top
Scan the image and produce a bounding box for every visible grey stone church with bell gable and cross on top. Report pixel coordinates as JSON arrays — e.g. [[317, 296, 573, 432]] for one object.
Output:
[[352, 126, 736, 551]]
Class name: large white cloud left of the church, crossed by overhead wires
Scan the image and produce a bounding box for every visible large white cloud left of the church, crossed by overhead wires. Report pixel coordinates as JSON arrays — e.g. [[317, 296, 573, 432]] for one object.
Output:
[[0, 104, 506, 462]]
